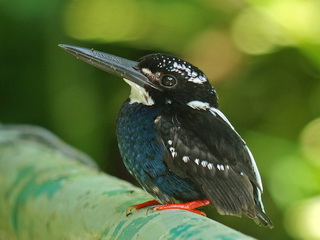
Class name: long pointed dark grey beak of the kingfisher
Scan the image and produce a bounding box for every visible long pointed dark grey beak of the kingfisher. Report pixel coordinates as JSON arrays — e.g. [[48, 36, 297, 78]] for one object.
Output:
[[59, 44, 159, 89]]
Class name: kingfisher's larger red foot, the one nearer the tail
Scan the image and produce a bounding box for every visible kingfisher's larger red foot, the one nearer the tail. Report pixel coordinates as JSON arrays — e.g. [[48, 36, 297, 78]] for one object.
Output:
[[155, 200, 210, 216]]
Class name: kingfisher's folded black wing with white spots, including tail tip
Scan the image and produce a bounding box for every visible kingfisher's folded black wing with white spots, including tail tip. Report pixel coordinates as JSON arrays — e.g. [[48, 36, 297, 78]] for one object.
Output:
[[156, 105, 271, 225]]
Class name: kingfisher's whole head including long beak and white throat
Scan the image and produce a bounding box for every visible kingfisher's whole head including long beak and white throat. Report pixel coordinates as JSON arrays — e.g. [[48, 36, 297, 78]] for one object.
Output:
[[59, 45, 218, 108]]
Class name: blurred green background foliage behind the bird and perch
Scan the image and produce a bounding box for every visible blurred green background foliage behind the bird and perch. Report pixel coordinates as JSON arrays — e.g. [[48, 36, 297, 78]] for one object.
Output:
[[0, 0, 320, 240]]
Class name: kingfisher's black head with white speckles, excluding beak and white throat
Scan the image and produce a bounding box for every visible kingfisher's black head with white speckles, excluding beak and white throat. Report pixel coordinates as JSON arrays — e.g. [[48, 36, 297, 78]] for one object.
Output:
[[137, 53, 217, 107]]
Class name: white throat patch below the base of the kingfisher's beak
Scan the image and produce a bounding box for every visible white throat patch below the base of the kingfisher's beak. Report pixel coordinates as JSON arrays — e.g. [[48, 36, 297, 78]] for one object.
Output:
[[124, 79, 154, 106]]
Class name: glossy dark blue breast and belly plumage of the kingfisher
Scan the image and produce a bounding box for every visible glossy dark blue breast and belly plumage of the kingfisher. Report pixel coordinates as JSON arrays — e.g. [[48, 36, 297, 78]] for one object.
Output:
[[117, 101, 203, 204]]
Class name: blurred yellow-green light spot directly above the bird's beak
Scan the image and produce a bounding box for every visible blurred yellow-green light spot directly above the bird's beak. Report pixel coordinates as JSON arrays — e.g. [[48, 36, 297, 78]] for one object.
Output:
[[65, 0, 141, 42]]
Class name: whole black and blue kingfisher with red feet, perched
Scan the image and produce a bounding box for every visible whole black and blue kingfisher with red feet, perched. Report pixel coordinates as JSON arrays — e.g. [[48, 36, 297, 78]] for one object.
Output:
[[59, 44, 273, 227]]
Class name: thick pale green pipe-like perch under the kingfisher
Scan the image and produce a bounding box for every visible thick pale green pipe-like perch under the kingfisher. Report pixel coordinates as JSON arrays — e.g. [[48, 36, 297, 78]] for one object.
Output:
[[0, 125, 253, 240]]
